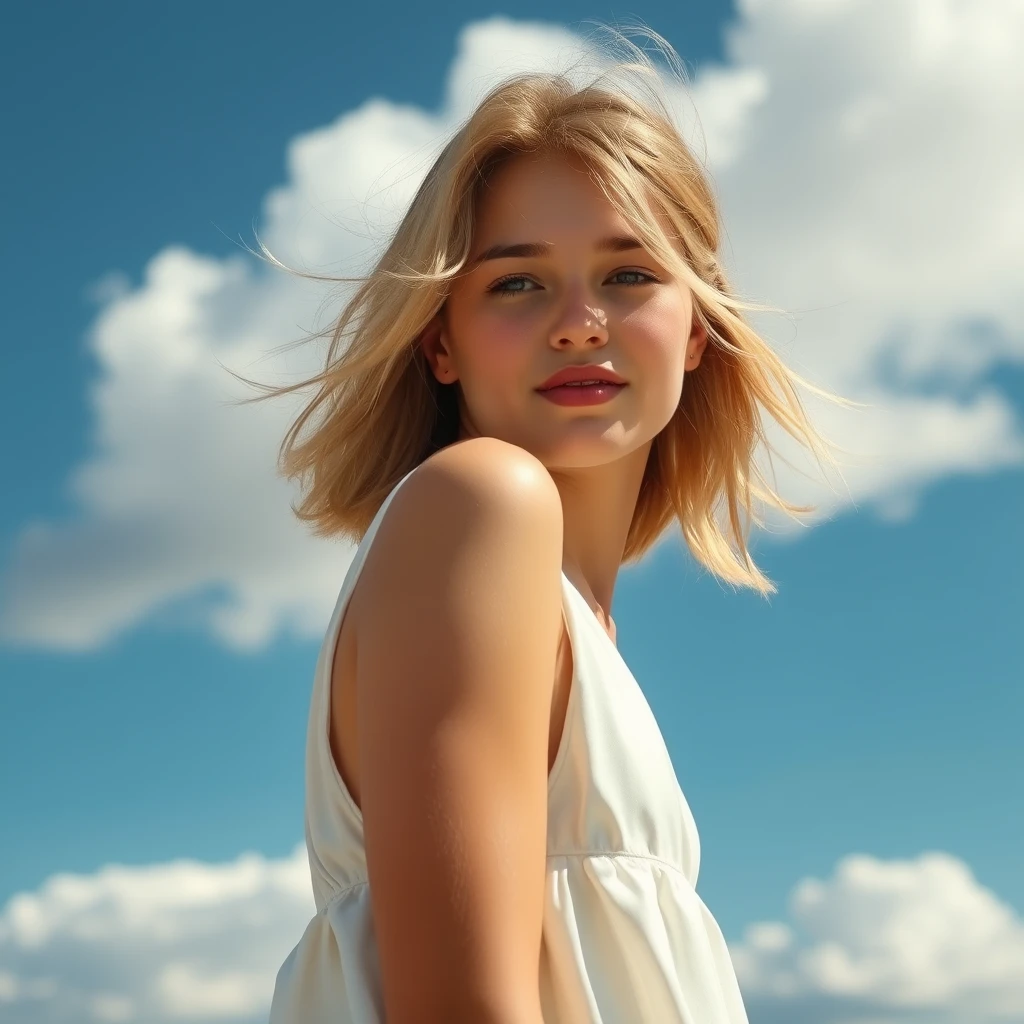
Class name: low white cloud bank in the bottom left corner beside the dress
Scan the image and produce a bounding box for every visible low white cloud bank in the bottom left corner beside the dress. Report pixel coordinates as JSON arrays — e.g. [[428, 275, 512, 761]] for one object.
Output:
[[0, 844, 315, 1024]]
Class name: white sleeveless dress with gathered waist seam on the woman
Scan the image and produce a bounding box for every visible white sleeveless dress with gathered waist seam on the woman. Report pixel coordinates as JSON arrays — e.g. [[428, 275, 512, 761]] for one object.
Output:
[[270, 473, 748, 1024]]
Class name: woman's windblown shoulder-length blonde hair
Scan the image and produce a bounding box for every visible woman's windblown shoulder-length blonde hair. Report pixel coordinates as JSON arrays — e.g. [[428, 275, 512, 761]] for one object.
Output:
[[234, 22, 829, 594]]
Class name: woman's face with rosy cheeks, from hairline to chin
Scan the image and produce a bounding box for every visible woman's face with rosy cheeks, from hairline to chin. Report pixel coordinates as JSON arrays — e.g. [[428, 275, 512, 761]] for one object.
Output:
[[422, 149, 707, 468]]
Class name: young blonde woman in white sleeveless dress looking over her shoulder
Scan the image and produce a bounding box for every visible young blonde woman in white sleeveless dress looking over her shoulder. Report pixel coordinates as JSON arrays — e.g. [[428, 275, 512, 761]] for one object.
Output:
[[258, 28, 823, 1024]]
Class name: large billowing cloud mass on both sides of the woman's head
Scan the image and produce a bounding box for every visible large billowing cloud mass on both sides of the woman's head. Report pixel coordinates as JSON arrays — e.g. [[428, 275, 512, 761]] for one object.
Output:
[[0, 0, 1024, 649]]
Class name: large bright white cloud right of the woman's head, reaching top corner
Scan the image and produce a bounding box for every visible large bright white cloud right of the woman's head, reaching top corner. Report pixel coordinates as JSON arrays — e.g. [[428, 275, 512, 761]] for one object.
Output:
[[694, 0, 1024, 528]]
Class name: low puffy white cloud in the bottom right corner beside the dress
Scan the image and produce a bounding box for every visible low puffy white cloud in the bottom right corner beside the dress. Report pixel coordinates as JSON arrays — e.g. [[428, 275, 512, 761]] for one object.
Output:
[[730, 853, 1024, 1024]]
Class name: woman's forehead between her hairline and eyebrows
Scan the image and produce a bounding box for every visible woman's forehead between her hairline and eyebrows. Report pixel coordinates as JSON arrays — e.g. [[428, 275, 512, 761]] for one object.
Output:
[[474, 154, 630, 246]]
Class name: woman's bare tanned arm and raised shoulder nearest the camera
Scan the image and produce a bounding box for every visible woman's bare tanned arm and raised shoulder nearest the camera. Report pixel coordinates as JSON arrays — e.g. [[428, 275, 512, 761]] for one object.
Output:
[[356, 438, 562, 1024]]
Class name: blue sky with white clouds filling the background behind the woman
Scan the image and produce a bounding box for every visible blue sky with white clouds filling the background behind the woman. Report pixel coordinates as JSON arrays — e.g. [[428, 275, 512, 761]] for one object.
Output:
[[0, 0, 1024, 1024]]
